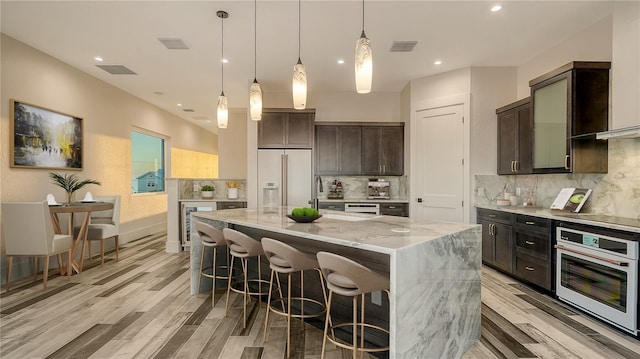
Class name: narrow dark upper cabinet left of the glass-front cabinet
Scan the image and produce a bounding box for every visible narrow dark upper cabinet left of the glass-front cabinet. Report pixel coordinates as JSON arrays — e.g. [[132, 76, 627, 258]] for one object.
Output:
[[496, 97, 533, 175]]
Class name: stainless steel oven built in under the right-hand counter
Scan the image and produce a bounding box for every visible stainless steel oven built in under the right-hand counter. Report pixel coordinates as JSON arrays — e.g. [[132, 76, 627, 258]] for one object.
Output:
[[556, 226, 640, 335]]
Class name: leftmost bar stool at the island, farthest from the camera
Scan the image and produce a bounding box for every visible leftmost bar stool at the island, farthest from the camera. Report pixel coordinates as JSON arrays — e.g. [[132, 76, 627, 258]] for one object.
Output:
[[196, 222, 230, 307]]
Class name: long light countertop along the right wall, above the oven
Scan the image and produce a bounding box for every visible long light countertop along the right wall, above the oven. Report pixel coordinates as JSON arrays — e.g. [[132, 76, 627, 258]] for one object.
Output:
[[476, 204, 640, 233]]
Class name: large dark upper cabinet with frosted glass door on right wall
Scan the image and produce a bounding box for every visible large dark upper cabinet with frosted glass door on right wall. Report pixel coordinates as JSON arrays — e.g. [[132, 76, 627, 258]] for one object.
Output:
[[529, 62, 611, 173]]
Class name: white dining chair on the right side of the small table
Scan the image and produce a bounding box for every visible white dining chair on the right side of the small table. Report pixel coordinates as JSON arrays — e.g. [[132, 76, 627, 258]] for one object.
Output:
[[75, 195, 120, 266]]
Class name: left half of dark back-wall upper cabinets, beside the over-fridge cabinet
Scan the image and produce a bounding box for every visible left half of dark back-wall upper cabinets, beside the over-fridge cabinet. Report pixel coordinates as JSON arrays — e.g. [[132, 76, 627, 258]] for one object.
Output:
[[315, 125, 362, 176]]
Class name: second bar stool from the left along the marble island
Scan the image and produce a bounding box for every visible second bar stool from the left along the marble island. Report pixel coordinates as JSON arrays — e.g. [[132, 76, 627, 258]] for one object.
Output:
[[222, 228, 269, 329]]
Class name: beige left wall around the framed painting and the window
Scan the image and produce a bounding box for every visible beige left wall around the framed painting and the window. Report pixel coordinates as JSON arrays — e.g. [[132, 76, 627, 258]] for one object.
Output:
[[0, 34, 218, 242]]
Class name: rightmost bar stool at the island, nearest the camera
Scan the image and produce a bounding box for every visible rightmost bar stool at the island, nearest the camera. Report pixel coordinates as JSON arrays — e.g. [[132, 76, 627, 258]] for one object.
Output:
[[317, 252, 391, 359]]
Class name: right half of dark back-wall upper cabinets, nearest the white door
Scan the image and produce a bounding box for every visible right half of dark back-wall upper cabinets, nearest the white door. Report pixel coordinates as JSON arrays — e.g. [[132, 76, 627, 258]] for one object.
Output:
[[362, 125, 404, 176]]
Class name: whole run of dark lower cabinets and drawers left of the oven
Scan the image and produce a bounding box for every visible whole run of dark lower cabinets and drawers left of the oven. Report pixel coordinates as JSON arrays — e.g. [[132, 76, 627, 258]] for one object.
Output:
[[478, 208, 553, 291]]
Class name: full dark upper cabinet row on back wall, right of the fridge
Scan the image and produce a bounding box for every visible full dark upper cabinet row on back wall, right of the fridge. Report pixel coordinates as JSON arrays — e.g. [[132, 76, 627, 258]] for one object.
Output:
[[315, 122, 404, 176]]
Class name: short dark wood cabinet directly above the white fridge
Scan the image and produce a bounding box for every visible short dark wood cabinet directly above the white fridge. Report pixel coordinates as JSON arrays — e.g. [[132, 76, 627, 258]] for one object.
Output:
[[258, 110, 315, 148]]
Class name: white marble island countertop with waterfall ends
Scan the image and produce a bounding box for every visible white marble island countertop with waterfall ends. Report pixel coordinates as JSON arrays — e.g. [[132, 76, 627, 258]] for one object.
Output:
[[191, 207, 481, 359]]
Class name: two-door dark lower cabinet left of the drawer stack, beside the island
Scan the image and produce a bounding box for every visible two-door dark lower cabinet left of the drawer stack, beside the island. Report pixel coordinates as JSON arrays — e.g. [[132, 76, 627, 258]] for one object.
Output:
[[478, 209, 513, 273]]
